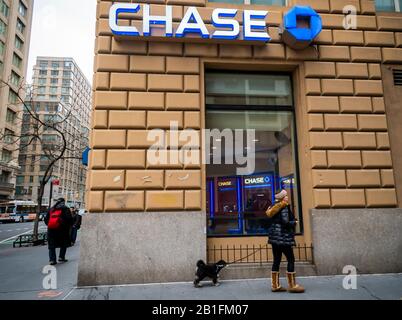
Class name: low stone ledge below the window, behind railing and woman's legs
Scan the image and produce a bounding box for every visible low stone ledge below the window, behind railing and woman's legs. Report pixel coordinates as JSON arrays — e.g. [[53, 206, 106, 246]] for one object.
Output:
[[220, 259, 317, 280]]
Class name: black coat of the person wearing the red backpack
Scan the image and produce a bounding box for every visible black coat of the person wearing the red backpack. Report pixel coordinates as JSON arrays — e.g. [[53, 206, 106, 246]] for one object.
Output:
[[45, 202, 73, 249]]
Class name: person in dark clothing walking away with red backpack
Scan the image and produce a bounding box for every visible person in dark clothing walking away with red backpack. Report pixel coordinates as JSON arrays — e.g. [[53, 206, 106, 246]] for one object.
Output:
[[45, 198, 73, 265]]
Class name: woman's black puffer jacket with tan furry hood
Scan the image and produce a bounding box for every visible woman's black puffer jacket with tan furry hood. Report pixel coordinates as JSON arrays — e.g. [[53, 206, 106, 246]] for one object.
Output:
[[268, 203, 296, 246]]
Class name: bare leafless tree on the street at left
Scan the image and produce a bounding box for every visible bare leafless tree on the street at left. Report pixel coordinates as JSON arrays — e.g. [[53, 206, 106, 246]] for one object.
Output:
[[0, 80, 88, 240]]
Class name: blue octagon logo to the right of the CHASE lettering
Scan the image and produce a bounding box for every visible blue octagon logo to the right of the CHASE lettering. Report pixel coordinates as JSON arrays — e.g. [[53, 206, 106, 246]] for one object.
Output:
[[282, 6, 322, 49]]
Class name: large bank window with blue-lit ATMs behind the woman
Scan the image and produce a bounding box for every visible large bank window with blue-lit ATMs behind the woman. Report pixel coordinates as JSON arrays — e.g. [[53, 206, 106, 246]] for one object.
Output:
[[206, 71, 302, 237]]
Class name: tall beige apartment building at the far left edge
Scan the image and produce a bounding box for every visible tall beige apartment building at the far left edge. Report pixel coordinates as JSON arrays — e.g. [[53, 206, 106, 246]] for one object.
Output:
[[0, 0, 34, 200]]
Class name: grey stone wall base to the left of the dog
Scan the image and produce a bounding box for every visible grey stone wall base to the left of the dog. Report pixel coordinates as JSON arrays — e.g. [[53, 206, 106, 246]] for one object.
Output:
[[78, 212, 206, 286]]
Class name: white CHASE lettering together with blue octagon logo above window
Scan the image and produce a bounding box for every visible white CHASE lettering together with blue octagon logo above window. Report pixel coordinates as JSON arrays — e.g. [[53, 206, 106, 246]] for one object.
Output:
[[109, 3, 322, 43]]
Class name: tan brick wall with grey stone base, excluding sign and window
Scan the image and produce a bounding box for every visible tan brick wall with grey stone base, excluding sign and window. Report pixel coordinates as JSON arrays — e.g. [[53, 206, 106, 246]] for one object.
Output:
[[79, 0, 402, 284]]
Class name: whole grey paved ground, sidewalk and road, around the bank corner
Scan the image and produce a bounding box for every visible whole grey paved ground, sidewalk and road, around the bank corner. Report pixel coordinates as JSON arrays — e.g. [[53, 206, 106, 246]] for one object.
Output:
[[0, 228, 402, 300]]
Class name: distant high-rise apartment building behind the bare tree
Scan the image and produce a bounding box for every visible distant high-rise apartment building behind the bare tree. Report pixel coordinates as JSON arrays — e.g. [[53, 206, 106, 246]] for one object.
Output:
[[16, 57, 92, 207]]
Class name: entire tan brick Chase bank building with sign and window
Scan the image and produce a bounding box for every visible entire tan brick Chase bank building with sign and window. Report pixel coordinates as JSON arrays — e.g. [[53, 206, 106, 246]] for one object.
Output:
[[79, 0, 402, 285]]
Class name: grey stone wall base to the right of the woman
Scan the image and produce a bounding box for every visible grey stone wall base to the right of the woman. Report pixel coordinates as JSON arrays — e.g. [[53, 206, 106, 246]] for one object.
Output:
[[311, 208, 402, 275]]
